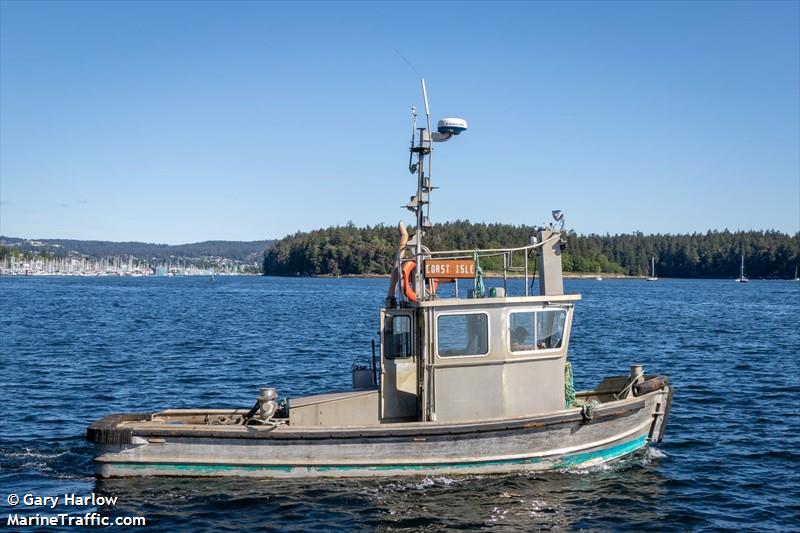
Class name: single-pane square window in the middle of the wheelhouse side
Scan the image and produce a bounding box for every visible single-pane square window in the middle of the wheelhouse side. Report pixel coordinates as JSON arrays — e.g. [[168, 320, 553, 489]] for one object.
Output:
[[436, 313, 489, 357]]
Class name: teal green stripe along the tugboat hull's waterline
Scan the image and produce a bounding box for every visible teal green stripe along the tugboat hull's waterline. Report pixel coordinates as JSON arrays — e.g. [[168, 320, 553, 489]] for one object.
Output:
[[104, 436, 647, 474]]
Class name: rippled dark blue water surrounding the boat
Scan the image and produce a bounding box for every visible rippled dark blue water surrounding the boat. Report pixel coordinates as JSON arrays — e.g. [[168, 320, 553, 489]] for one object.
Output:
[[0, 277, 800, 532]]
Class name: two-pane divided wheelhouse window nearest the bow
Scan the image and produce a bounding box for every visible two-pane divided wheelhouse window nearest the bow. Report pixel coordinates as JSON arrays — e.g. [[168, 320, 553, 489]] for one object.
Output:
[[508, 309, 567, 352]]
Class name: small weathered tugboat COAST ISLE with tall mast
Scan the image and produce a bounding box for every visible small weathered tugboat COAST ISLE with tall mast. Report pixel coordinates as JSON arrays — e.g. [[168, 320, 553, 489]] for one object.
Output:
[[86, 80, 673, 477]]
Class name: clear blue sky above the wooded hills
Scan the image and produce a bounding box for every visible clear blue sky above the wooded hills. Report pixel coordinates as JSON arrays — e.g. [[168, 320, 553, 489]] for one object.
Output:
[[0, 1, 800, 243]]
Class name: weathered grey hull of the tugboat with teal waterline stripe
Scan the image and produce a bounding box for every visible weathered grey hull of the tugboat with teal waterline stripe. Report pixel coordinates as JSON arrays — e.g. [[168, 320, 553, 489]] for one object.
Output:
[[89, 387, 672, 478]]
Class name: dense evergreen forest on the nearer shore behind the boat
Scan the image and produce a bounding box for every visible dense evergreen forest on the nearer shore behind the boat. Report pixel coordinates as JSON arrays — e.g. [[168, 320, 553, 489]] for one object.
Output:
[[263, 221, 800, 278]]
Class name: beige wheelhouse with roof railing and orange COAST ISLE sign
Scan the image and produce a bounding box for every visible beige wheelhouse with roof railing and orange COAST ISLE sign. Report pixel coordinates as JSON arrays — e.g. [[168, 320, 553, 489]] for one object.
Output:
[[379, 224, 580, 423]]
